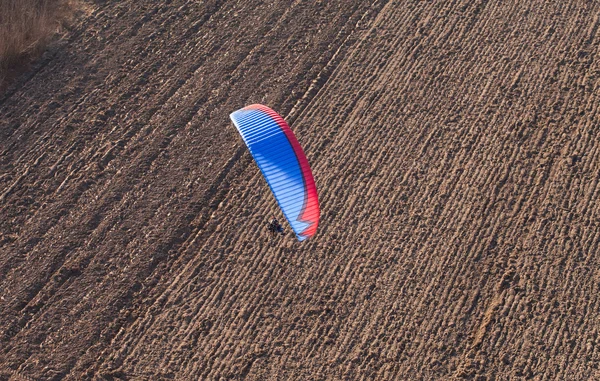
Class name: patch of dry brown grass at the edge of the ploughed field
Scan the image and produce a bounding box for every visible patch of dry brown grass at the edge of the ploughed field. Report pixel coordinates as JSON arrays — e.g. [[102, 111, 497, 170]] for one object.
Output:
[[0, 0, 74, 84]]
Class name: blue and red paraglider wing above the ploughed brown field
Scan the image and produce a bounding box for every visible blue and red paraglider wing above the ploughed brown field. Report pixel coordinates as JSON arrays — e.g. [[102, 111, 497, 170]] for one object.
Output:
[[230, 104, 320, 241]]
